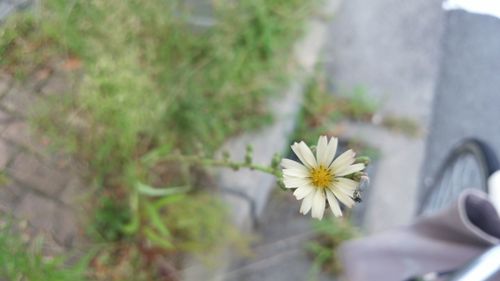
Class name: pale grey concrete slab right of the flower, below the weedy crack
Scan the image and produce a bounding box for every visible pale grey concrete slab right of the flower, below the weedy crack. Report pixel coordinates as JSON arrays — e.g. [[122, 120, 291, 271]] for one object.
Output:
[[342, 122, 424, 233]]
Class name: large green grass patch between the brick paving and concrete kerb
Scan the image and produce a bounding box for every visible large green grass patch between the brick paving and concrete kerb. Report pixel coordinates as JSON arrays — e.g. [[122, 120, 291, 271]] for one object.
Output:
[[0, 0, 320, 280]]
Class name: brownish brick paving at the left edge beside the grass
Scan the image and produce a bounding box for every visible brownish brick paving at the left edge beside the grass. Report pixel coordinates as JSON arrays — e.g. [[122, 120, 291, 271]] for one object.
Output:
[[0, 63, 85, 252]]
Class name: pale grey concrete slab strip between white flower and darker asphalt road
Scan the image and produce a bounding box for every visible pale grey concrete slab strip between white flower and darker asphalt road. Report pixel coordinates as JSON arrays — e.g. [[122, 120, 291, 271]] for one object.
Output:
[[325, 0, 444, 233]]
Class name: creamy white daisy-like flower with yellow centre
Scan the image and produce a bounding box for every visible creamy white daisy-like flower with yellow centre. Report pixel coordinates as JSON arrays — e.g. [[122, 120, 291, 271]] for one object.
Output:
[[281, 136, 365, 220]]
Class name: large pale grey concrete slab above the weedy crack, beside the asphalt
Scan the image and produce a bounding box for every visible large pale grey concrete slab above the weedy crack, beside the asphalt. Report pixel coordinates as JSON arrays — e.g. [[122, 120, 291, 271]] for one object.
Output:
[[325, 0, 443, 124]]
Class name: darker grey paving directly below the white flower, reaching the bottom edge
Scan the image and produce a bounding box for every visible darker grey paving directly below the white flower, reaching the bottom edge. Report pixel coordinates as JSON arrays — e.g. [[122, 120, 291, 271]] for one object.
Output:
[[223, 191, 335, 281]]
